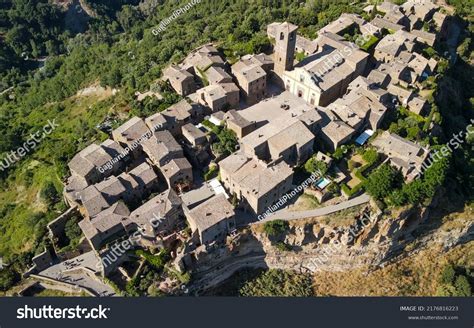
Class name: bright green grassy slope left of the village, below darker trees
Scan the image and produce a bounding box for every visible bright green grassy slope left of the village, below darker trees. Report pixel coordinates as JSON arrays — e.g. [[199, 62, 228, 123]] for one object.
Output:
[[0, 95, 112, 260]]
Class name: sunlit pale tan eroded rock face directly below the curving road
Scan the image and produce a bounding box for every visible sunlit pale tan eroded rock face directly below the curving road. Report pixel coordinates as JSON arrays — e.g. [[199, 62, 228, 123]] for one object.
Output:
[[254, 209, 421, 272]]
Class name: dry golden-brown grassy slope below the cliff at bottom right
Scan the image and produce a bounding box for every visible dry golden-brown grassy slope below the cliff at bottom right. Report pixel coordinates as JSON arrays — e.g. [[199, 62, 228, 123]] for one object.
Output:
[[314, 237, 474, 296]]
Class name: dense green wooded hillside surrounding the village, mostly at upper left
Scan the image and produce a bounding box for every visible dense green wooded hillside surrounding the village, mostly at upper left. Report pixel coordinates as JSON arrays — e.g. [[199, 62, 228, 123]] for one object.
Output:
[[0, 0, 474, 288]]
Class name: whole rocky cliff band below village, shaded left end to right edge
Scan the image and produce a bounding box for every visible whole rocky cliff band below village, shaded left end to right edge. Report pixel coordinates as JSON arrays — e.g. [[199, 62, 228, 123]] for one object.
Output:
[[184, 193, 474, 291]]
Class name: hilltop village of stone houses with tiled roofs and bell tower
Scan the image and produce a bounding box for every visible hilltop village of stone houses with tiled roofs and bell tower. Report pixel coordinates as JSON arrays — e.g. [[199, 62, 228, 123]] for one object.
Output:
[[18, 0, 456, 296]]
